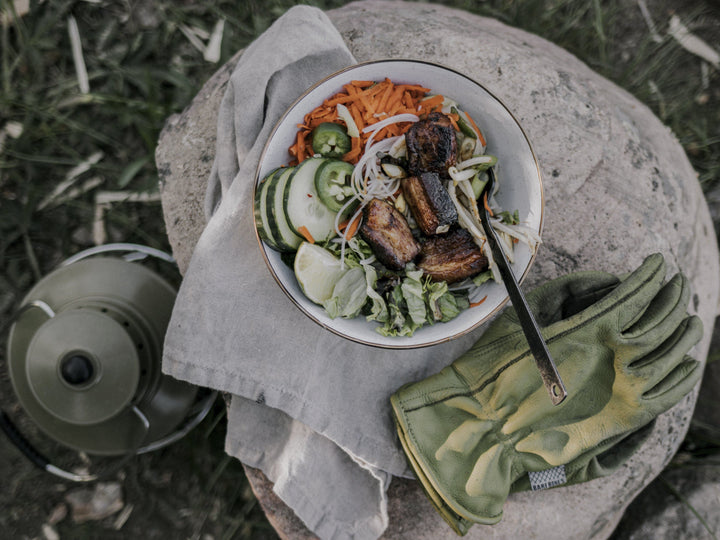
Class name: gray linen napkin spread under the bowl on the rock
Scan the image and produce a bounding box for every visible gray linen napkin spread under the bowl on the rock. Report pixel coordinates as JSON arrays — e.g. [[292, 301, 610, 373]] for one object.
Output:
[[163, 6, 486, 539]]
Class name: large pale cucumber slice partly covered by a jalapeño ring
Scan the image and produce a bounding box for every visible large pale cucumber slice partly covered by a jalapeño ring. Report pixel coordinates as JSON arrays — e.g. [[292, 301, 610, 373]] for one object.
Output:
[[285, 157, 336, 242]]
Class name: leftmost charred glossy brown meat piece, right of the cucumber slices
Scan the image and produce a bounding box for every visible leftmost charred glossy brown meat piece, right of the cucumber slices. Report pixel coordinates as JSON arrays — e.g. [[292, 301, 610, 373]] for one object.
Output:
[[360, 199, 420, 270]]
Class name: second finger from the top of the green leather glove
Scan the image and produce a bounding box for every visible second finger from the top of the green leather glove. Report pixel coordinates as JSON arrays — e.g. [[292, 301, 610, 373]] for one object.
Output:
[[622, 274, 690, 347]]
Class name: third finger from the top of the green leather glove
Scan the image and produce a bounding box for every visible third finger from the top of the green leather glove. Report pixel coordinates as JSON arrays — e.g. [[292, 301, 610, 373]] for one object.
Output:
[[628, 316, 703, 389]]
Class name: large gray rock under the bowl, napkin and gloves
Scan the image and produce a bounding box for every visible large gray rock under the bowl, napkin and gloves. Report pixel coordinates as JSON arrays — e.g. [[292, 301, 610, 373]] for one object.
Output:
[[156, 0, 719, 540]]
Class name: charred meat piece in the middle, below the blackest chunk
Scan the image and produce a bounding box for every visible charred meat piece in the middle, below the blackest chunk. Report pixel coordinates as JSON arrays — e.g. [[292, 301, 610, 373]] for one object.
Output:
[[401, 172, 457, 236]]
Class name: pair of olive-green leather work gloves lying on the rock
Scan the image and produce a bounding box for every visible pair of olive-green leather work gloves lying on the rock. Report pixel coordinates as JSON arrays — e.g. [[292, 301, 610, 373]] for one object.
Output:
[[391, 254, 702, 534]]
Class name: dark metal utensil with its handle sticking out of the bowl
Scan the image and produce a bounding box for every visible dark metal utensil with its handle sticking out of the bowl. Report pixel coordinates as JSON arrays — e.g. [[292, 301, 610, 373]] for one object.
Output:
[[478, 167, 567, 405]]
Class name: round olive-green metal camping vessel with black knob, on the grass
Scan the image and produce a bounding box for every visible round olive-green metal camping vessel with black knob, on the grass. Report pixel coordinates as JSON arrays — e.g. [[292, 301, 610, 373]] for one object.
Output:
[[0, 244, 216, 481]]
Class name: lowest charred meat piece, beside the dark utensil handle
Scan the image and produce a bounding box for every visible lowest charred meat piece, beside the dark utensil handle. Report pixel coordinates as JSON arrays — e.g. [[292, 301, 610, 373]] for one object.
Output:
[[417, 228, 488, 283]]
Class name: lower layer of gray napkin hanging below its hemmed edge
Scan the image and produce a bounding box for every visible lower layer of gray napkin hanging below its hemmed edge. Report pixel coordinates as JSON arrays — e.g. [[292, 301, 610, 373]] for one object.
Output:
[[225, 396, 390, 540]]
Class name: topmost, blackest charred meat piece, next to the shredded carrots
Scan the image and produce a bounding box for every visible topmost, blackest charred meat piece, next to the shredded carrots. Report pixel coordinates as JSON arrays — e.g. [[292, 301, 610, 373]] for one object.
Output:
[[405, 112, 457, 176]]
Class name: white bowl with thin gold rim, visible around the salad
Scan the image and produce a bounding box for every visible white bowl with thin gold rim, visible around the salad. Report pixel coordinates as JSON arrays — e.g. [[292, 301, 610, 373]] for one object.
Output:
[[256, 60, 544, 349]]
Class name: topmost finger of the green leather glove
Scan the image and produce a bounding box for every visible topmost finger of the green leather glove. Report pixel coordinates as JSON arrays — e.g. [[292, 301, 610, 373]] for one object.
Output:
[[588, 253, 665, 330]]
